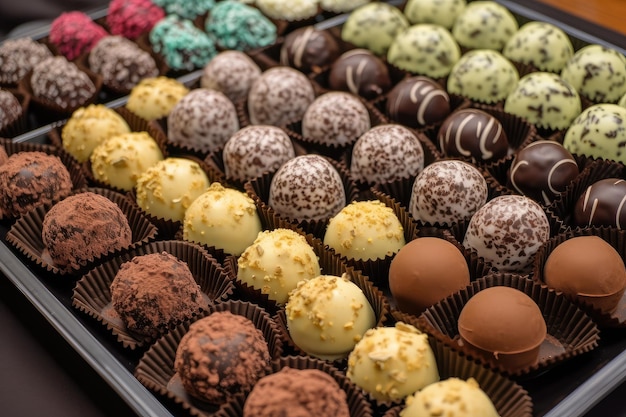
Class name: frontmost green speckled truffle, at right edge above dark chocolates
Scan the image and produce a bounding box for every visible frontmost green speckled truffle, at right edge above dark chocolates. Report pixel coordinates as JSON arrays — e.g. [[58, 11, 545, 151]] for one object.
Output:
[[563, 104, 626, 163]]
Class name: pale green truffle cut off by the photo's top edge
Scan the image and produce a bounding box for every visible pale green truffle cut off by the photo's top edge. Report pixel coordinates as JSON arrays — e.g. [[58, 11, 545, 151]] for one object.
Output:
[[404, 0, 467, 29]]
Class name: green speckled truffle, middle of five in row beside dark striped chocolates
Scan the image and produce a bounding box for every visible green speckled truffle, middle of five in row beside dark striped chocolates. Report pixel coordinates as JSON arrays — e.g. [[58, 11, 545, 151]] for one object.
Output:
[[448, 49, 519, 104]]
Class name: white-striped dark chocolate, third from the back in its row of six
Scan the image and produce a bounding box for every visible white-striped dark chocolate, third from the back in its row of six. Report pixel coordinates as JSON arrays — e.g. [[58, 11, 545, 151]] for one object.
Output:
[[385, 75, 450, 127]]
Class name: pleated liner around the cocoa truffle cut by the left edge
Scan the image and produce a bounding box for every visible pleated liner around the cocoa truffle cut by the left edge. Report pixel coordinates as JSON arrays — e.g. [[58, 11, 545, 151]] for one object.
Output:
[[0, 138, 87, 222]]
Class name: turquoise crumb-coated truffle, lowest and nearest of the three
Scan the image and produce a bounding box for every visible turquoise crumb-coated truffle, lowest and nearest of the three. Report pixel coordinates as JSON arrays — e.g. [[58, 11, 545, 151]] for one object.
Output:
[[150, 15, 217, 71]]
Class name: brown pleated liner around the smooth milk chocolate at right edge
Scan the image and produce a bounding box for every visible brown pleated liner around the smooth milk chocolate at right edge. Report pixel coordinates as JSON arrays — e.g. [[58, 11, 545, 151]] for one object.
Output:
[[532, 227, 626, 329]]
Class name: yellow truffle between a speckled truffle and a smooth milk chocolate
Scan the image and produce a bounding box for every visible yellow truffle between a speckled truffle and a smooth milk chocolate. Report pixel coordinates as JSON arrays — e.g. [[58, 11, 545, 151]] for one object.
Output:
[[324, 200, 406, 260]]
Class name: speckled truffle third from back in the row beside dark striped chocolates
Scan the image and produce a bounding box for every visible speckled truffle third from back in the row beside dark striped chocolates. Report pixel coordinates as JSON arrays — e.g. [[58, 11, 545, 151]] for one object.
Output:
[[302, 91, 371, 147]]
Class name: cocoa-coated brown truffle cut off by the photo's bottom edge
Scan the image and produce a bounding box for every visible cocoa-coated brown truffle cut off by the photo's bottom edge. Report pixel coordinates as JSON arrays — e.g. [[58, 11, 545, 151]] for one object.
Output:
[[243, 367, 350, 417]]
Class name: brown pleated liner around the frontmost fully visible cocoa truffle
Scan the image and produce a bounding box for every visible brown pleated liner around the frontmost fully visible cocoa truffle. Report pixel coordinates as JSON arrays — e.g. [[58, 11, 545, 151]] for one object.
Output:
[[134, 300, 283, 417]]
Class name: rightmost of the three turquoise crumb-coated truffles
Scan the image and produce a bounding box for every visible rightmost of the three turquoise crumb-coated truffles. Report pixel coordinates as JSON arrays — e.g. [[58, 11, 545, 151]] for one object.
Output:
[[205, 0, 276, 51]]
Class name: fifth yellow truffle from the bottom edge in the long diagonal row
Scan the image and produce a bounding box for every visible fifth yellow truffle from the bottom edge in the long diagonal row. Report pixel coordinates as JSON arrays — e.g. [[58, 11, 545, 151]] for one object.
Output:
[[183, 182, 261, 256]]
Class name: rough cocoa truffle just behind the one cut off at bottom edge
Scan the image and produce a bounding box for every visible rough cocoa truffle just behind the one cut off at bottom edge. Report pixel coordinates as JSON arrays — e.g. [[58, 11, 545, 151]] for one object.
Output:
[[174, 311, 270, 404]]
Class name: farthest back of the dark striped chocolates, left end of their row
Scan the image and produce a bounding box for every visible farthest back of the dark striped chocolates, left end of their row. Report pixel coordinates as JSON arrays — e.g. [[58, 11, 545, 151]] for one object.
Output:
[[280, 26, 340, 73]]
